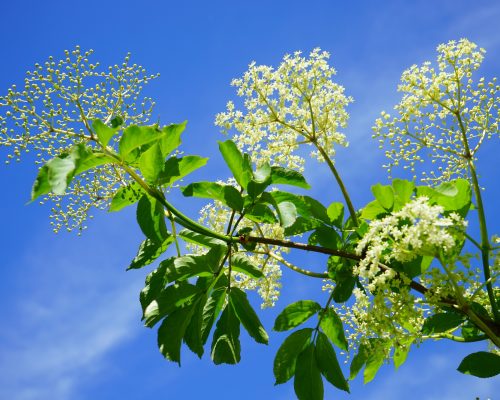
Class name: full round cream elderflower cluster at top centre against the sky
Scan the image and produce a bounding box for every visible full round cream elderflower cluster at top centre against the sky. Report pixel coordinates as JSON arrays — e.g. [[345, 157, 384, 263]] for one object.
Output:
[[215, 49, 353, 170]]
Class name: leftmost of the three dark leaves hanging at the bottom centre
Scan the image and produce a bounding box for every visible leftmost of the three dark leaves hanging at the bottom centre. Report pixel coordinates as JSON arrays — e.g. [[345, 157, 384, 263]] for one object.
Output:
[[273, 328, 313, 385]]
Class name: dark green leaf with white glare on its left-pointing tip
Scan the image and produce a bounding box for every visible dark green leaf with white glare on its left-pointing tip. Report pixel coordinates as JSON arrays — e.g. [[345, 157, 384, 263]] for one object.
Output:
[[144, 282, 200, 328]]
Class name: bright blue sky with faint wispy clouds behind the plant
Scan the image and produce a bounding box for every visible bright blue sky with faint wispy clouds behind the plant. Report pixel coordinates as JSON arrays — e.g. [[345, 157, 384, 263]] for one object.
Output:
[[0, 0, 500, 400]]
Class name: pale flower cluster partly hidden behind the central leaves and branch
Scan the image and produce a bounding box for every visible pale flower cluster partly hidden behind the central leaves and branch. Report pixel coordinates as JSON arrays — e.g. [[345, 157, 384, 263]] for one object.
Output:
[[195, 184, 288, 308]]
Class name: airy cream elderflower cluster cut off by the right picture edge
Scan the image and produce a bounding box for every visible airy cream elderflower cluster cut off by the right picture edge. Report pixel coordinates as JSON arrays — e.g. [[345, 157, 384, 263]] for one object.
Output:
[[373, 39, 500, 183]]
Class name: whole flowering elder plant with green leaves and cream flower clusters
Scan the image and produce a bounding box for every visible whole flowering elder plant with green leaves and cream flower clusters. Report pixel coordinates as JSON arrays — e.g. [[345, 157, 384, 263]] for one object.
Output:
[[0, 39, 500, 400]]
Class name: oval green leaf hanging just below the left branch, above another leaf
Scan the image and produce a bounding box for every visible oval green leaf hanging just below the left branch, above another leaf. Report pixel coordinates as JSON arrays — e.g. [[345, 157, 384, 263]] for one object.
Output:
[[137, 195, 170, 244]]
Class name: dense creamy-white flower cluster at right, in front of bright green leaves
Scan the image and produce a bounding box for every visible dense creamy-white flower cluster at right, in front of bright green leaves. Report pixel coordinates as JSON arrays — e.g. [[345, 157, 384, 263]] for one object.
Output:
[[355, 196, 467, 291]]
